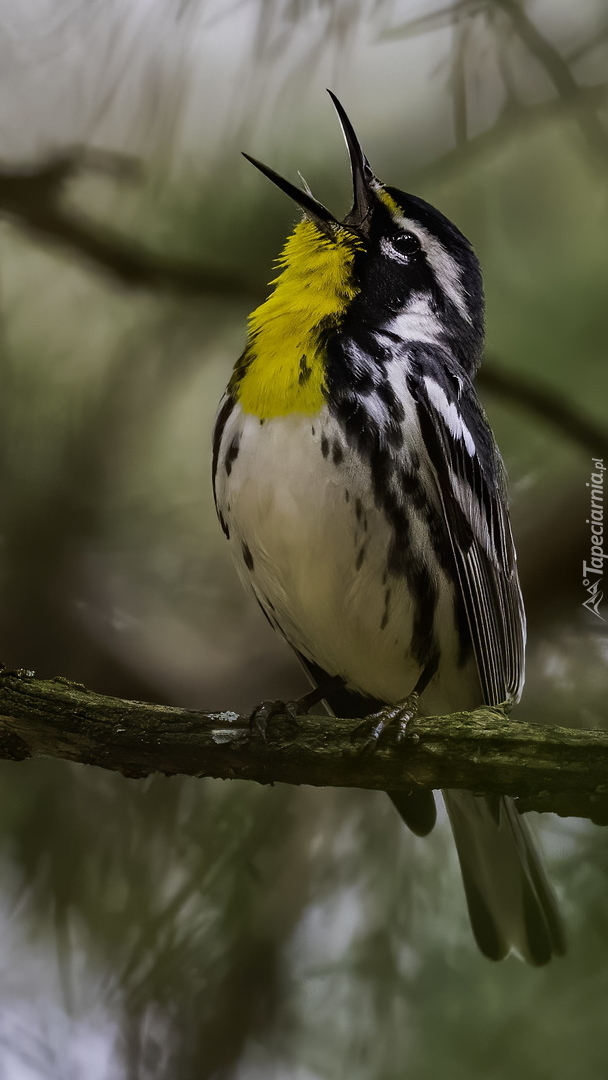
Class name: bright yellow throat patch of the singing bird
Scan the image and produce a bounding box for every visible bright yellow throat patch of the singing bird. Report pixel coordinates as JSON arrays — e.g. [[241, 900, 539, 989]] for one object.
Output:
[[230, 219, 362, 420]]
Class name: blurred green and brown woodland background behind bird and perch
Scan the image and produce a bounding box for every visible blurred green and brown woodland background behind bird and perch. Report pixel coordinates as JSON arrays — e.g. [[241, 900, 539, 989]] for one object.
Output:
[[0, 0, 608, 1080]]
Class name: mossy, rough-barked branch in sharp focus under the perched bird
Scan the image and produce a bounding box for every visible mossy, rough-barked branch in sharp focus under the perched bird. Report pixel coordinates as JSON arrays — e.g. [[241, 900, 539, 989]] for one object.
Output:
[[0, 672, 608, 824]]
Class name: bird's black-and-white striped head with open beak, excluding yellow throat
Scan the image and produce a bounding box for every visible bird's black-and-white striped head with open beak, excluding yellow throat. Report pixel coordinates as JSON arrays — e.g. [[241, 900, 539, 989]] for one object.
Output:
[[245, 91, 484, 375]]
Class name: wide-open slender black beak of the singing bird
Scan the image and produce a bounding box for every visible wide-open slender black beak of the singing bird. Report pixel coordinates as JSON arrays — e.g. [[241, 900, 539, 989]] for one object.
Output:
[[243, 90, 375, 237]]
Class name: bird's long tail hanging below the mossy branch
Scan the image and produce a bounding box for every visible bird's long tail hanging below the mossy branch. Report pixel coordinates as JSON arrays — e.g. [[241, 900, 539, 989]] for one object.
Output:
[[444, 791, 565, 967]]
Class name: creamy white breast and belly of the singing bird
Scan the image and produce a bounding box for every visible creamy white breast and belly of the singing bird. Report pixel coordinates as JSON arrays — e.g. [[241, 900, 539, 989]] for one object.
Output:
[[216, 406, 462, 701]]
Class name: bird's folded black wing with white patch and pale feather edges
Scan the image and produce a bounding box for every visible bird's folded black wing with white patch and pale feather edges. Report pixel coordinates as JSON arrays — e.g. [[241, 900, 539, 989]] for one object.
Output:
[[408, 354, 526, 705]]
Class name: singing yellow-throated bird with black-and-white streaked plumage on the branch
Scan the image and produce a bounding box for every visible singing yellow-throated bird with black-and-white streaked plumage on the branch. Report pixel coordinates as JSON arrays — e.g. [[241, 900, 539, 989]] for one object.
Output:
[[213, 91, 565, 966]]
